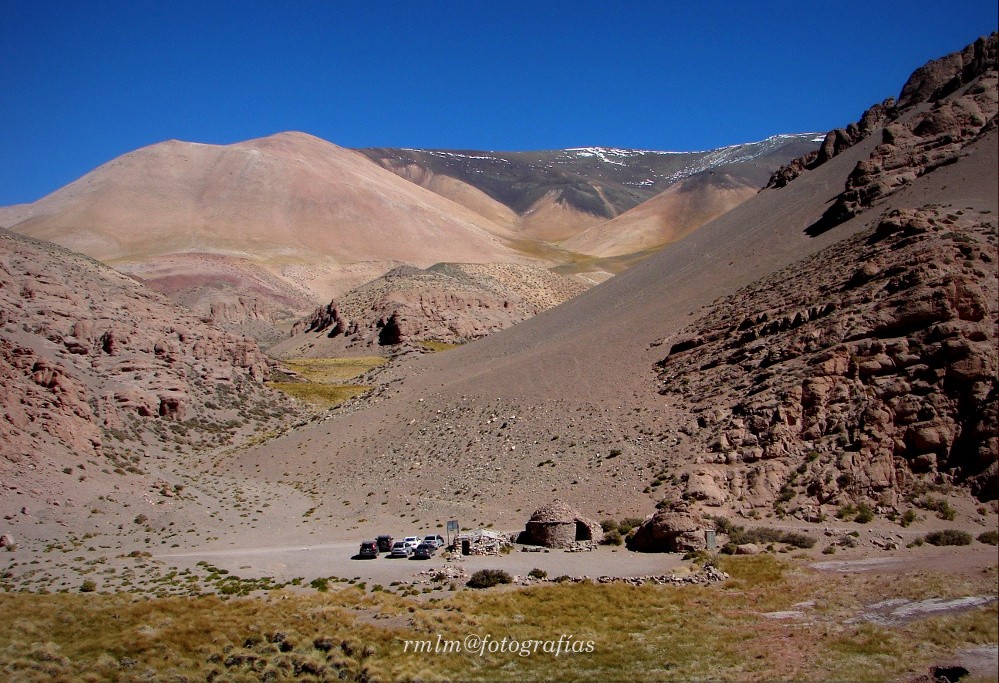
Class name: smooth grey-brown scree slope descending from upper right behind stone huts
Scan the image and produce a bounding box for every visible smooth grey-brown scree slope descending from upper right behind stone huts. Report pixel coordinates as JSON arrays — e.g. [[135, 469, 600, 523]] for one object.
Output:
[[230, 34, 999, 536]]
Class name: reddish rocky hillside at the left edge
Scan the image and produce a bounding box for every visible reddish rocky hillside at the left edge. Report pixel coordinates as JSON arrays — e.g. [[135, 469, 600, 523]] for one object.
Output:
[[0, 231, 294, 493]]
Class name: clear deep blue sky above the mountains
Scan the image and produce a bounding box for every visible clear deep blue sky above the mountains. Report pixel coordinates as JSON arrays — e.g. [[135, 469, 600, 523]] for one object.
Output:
[[0, 0, 999, 205]]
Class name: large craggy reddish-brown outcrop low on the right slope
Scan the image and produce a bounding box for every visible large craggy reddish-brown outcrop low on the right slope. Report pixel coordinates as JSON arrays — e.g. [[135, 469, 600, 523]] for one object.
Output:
[[660, 206, 999, 506]]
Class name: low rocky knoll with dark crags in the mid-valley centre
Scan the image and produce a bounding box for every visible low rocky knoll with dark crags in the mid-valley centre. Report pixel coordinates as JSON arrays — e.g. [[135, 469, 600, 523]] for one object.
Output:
[[271, 263, 587, 356]]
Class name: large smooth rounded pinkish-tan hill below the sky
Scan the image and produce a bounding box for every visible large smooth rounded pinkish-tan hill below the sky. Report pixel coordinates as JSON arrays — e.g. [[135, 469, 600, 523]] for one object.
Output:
[[8, 133, 532, 334]]
